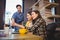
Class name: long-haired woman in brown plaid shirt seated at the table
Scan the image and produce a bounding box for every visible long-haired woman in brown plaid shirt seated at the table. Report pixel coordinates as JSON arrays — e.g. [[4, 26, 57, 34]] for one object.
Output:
[[29, 10, 46, 38]]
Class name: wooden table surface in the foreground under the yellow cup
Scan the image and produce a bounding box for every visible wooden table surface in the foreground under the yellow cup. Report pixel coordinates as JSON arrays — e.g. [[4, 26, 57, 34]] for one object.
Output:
[[0, 33, 42, 40]]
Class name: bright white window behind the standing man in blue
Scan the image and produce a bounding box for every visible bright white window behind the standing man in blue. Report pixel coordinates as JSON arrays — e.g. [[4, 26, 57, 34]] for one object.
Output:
[[5, 0, 22, 24]]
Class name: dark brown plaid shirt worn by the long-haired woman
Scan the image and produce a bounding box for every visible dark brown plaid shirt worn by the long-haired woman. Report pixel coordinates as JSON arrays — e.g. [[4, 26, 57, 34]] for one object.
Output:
[[29, 18, 46, 36]]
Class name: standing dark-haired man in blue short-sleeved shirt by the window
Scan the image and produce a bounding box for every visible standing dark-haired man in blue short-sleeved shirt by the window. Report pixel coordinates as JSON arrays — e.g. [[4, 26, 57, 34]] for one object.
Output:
[[12, 4, 24, 31]]
